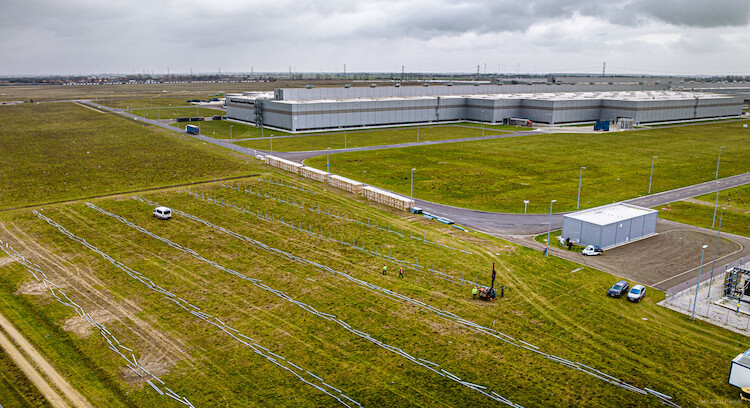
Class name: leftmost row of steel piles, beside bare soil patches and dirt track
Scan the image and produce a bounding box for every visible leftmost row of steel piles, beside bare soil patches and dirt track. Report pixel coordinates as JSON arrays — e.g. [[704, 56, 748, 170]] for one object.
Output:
[[0, 237, 194, 408]]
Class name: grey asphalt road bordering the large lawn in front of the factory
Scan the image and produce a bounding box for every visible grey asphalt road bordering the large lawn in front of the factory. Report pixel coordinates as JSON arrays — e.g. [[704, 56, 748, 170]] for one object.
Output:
[[83, 100, 750, 235]]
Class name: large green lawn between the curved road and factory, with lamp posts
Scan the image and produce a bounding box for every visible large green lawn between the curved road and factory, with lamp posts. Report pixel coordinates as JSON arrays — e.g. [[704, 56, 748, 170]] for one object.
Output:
[[306, 122, 750, 212]]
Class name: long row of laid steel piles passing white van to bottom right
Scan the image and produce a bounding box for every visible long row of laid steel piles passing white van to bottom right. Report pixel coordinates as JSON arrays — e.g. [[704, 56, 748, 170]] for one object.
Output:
[[133, 197, 679, 407]]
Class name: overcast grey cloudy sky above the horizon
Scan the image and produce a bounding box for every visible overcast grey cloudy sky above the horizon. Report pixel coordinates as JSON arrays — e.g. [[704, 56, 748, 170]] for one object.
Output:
[[0, 0, 750, 75]]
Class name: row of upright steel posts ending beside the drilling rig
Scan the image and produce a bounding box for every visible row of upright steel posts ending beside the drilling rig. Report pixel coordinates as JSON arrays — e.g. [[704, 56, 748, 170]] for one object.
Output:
[[176, 189, 475, 285]]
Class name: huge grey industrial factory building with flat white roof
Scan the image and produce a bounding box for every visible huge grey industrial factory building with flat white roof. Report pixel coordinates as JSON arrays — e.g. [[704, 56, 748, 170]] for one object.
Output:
[[226, 84, 744, 132]]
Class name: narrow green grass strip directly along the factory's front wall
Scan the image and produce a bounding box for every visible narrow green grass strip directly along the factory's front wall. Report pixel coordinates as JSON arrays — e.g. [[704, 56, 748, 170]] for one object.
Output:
[[237, 125, 504, 152]]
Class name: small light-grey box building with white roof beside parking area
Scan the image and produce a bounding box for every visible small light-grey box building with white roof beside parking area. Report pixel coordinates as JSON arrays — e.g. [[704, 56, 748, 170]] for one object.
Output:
[[561, 203, 659, 249]]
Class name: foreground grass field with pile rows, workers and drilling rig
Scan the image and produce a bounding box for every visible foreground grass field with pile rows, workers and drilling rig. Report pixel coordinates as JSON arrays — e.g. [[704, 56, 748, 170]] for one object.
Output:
[[0, 172, 746, 407]]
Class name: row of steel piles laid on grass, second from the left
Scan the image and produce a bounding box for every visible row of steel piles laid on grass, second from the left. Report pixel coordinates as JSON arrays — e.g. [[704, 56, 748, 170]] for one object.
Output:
[[34, 209, 362, 408]]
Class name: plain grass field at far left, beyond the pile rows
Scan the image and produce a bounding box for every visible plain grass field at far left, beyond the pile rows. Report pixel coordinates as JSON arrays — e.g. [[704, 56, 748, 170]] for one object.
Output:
[[0, 103, 254, 209]]
